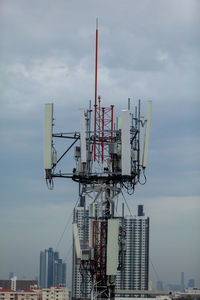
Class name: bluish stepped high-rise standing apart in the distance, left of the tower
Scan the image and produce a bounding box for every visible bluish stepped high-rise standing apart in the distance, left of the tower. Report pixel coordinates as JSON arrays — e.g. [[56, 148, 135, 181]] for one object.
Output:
[[39, 248, 66, 288]]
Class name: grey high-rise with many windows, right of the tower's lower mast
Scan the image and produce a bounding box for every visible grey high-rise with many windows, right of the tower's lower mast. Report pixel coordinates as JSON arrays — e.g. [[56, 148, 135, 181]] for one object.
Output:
[[116, 205, 149, 290]]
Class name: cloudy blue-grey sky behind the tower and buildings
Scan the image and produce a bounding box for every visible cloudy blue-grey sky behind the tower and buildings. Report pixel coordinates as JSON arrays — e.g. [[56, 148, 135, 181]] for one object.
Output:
[[0, 0, 200, 285]]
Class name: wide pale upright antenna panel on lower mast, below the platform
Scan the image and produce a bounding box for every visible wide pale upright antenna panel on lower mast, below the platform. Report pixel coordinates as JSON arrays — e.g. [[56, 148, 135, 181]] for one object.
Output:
[[106, 219, 119, 275]]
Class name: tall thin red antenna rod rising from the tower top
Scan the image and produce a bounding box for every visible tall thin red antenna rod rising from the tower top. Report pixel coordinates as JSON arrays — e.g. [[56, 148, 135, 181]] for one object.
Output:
[[94, 18, 98, 161]]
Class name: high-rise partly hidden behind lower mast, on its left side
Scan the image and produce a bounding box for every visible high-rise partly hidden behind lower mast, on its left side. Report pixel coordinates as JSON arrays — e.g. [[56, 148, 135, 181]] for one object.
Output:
[[72, 196, 91, 299]]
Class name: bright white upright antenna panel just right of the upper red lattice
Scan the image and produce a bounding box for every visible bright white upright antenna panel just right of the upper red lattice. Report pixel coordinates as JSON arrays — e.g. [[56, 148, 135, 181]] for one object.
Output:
[[121, 110, 131, 176]]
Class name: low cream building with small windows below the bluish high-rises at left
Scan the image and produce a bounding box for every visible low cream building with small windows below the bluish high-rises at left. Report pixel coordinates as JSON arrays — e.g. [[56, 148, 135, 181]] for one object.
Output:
[[40, 287, 69, 300]]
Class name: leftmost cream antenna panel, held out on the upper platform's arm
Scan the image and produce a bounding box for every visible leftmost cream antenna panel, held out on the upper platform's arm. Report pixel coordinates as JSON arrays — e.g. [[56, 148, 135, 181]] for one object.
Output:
[[44, 103, 53, 170]]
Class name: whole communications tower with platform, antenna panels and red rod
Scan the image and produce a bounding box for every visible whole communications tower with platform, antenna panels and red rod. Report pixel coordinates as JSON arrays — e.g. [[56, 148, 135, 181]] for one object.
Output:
[[44, 21, 152, 300]]
